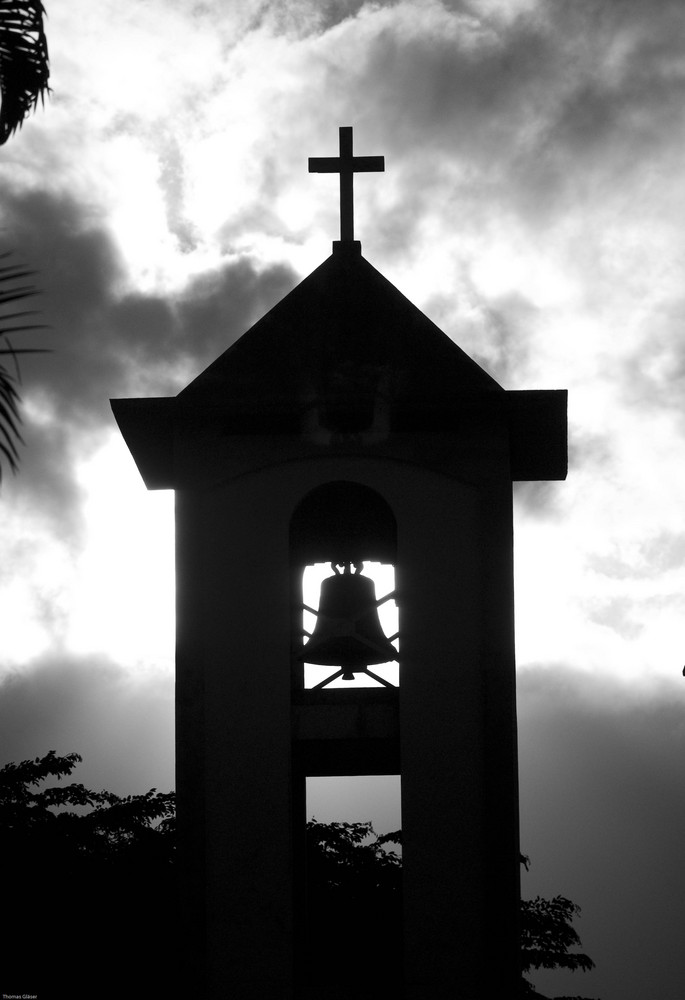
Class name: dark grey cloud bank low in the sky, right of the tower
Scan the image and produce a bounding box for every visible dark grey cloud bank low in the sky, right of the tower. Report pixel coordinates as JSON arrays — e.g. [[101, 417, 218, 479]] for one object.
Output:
[[519, 667, 685, 1000]]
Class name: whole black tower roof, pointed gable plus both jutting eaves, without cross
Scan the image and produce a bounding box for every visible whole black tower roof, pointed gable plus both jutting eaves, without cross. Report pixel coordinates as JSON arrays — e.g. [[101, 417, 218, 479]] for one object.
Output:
[[112, 240, 566, 488]]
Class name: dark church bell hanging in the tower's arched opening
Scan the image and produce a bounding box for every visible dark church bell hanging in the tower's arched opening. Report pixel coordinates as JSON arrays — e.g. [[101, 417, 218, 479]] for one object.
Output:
[[301, 563, 398, 680]]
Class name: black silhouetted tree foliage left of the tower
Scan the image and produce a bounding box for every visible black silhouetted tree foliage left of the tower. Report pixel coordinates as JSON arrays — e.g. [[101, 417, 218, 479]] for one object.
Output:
[[0, 751, 175, 1000]]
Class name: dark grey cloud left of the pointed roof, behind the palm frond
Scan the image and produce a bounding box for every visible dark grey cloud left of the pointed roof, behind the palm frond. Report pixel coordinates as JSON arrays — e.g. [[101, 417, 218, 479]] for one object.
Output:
[[2, 192, 295, 533]]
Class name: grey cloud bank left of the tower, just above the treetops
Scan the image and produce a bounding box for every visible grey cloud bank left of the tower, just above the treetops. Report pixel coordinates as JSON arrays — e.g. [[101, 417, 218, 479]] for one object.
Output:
[[0, 653, 174, 794]]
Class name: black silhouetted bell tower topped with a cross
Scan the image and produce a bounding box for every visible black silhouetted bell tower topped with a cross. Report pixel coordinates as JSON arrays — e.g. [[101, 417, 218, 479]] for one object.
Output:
[[112, 129, 566, 1000]]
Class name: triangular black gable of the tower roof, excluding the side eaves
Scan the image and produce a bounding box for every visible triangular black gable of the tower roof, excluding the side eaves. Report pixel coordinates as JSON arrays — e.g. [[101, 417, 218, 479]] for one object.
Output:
[[178, 242, 503, 419]]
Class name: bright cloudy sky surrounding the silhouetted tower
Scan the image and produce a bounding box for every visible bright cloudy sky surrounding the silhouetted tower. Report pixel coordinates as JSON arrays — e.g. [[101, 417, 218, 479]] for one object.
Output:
[[0, 0, 685, 1000]]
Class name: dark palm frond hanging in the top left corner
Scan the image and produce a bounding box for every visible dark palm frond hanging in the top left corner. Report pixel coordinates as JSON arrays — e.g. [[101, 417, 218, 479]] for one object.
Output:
[[0, 0, 50, 146]]
